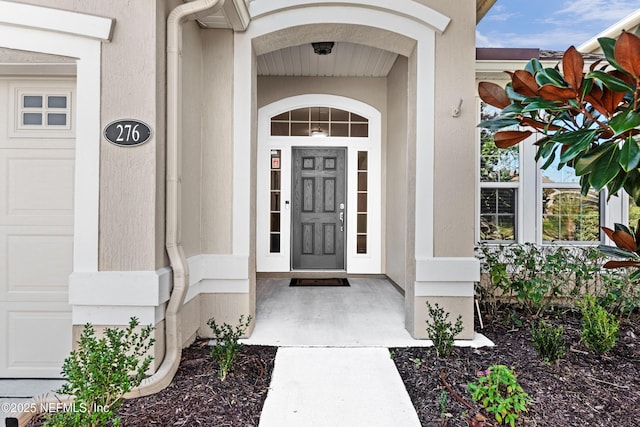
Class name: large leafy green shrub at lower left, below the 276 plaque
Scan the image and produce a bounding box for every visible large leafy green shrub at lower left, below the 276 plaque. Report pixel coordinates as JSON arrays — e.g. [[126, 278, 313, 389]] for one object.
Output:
[[45, 317, 154, 427]]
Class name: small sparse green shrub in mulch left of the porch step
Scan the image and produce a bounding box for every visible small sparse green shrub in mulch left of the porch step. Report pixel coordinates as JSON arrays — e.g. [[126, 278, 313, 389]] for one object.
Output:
[[208, 315, 251, 381]]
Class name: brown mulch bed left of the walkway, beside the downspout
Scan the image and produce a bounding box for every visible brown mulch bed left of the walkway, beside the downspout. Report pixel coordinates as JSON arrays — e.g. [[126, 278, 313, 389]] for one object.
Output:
[[29, 340, 277, 427]]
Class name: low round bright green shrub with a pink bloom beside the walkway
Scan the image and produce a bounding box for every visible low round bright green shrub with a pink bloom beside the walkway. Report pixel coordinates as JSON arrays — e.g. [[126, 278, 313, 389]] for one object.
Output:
[[467, 365, 531, 427]]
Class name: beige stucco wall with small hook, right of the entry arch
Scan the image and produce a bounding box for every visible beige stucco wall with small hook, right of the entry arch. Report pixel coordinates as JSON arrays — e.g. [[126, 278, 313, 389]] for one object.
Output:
[[424, 0, 476, 256]]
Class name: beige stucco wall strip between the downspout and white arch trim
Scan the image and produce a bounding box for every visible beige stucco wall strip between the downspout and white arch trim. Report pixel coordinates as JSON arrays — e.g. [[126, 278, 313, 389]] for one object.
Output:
[[176, 26, 239, 258]]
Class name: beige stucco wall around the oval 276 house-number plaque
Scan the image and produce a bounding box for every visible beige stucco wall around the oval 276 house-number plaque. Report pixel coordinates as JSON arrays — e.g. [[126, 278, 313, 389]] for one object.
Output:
[[17, 0, 171, 271]]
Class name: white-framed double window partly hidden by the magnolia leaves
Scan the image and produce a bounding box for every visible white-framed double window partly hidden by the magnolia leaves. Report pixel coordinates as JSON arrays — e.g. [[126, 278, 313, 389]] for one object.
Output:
[[478, 103, 605, 243]]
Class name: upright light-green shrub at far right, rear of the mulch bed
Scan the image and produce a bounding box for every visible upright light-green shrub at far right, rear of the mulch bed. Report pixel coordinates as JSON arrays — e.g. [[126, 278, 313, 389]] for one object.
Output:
[[580, 295, 619, 354]]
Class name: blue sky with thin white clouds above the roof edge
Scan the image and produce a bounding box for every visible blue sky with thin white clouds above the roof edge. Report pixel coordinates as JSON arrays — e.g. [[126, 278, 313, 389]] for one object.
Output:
[[476, 0, 640, 51]]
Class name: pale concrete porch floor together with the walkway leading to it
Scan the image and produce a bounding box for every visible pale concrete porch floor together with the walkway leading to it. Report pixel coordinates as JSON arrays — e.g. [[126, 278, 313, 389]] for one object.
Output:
[[250, 279, 493, 427]]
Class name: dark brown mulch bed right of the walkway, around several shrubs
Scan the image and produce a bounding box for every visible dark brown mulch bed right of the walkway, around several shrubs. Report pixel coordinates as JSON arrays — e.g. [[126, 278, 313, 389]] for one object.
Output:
[[392, 311, 640, 427]]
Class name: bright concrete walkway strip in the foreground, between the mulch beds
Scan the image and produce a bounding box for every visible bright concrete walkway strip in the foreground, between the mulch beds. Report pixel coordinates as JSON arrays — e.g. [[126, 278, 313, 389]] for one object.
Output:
[[260, 348, 420, 427]]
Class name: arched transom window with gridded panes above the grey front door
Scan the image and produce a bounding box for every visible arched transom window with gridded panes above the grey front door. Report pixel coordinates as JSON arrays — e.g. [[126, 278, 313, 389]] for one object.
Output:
[[271, 107, 369, 138]]
